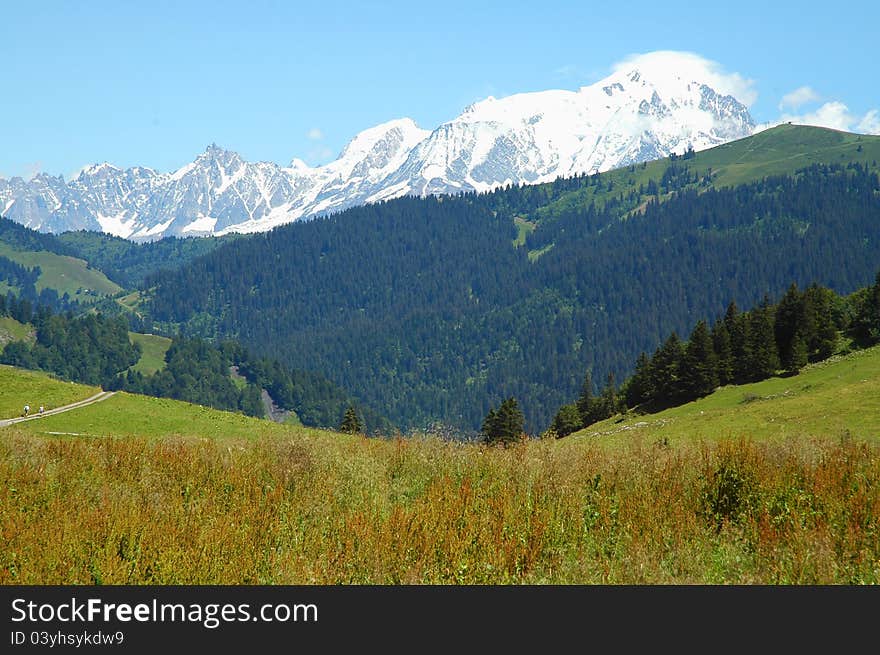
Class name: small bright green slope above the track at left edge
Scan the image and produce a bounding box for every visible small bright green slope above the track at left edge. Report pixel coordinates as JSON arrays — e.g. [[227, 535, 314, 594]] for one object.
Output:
[[0, 365, 100, 418]]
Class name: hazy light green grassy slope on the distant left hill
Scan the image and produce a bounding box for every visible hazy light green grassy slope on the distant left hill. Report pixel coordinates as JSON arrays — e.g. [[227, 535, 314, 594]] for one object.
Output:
[[0, 243, 122, 300]]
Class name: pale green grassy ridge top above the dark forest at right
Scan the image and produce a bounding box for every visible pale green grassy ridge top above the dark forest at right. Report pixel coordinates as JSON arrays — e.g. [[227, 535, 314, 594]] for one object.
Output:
[[535, 124, 880, 220]]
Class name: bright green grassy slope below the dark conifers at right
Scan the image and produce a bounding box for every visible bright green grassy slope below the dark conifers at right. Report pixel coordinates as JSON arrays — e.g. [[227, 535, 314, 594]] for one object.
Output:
[[566, 347, 880, 446]]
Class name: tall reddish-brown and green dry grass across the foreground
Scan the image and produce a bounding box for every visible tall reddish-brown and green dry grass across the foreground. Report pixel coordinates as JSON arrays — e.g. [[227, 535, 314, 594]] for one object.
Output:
[[0, 432, 880, 584]]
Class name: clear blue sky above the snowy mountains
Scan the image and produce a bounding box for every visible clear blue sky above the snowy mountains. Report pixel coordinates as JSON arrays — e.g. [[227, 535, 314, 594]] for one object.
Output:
[[0, 0, 880, 178]]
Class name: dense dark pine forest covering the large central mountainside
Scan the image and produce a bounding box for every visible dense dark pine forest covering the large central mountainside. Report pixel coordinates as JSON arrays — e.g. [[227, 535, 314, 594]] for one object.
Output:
[[145, 162, 880, 432]]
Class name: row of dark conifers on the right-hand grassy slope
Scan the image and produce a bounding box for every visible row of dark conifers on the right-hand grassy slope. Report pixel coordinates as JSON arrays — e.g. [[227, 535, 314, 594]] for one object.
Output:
[[551, 273, 880, 437]]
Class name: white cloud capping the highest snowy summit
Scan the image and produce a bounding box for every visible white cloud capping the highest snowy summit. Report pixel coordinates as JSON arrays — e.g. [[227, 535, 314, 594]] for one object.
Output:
[[612, 50, 758, 107]]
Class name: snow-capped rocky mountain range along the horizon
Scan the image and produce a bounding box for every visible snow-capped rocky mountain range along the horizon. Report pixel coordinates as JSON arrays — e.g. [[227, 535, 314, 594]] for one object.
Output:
[[0, 59, 755, 240]]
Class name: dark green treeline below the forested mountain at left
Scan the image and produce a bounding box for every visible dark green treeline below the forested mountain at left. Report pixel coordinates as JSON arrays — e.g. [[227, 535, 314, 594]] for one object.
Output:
[[0, 294, 391, 433]]
